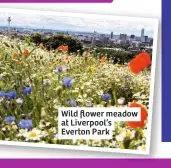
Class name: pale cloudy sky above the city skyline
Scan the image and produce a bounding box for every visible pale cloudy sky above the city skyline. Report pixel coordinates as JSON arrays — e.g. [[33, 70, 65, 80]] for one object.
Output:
[[0, 10, 154, 37]]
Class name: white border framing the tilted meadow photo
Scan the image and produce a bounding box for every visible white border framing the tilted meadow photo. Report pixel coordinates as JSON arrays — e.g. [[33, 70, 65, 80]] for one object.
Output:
[[0, 8, 159, 155]]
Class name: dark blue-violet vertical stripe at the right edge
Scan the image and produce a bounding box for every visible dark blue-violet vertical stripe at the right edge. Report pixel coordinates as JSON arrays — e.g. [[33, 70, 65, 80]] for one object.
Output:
[[161, 0, 171, 142]]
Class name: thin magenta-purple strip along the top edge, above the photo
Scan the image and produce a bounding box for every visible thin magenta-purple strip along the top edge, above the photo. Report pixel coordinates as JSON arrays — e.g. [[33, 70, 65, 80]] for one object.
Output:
[[0, 0, 113, 3]]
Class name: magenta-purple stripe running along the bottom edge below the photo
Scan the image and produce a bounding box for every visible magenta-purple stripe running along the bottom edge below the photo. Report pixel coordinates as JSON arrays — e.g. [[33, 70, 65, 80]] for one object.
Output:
[[0, 159, 171, 168]]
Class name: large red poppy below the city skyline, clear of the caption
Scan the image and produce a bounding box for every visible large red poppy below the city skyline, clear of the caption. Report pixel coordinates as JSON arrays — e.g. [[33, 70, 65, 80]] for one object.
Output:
[[128, 52, 151, 74]]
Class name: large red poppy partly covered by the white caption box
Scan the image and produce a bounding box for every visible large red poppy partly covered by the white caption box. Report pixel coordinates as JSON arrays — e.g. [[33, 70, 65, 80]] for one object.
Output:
[[127, 102, 148, 129]]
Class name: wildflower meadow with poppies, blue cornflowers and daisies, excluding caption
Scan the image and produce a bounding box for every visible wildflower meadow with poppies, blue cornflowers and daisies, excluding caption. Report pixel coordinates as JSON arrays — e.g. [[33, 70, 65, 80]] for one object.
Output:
[[0, 36, 151, 150]]
